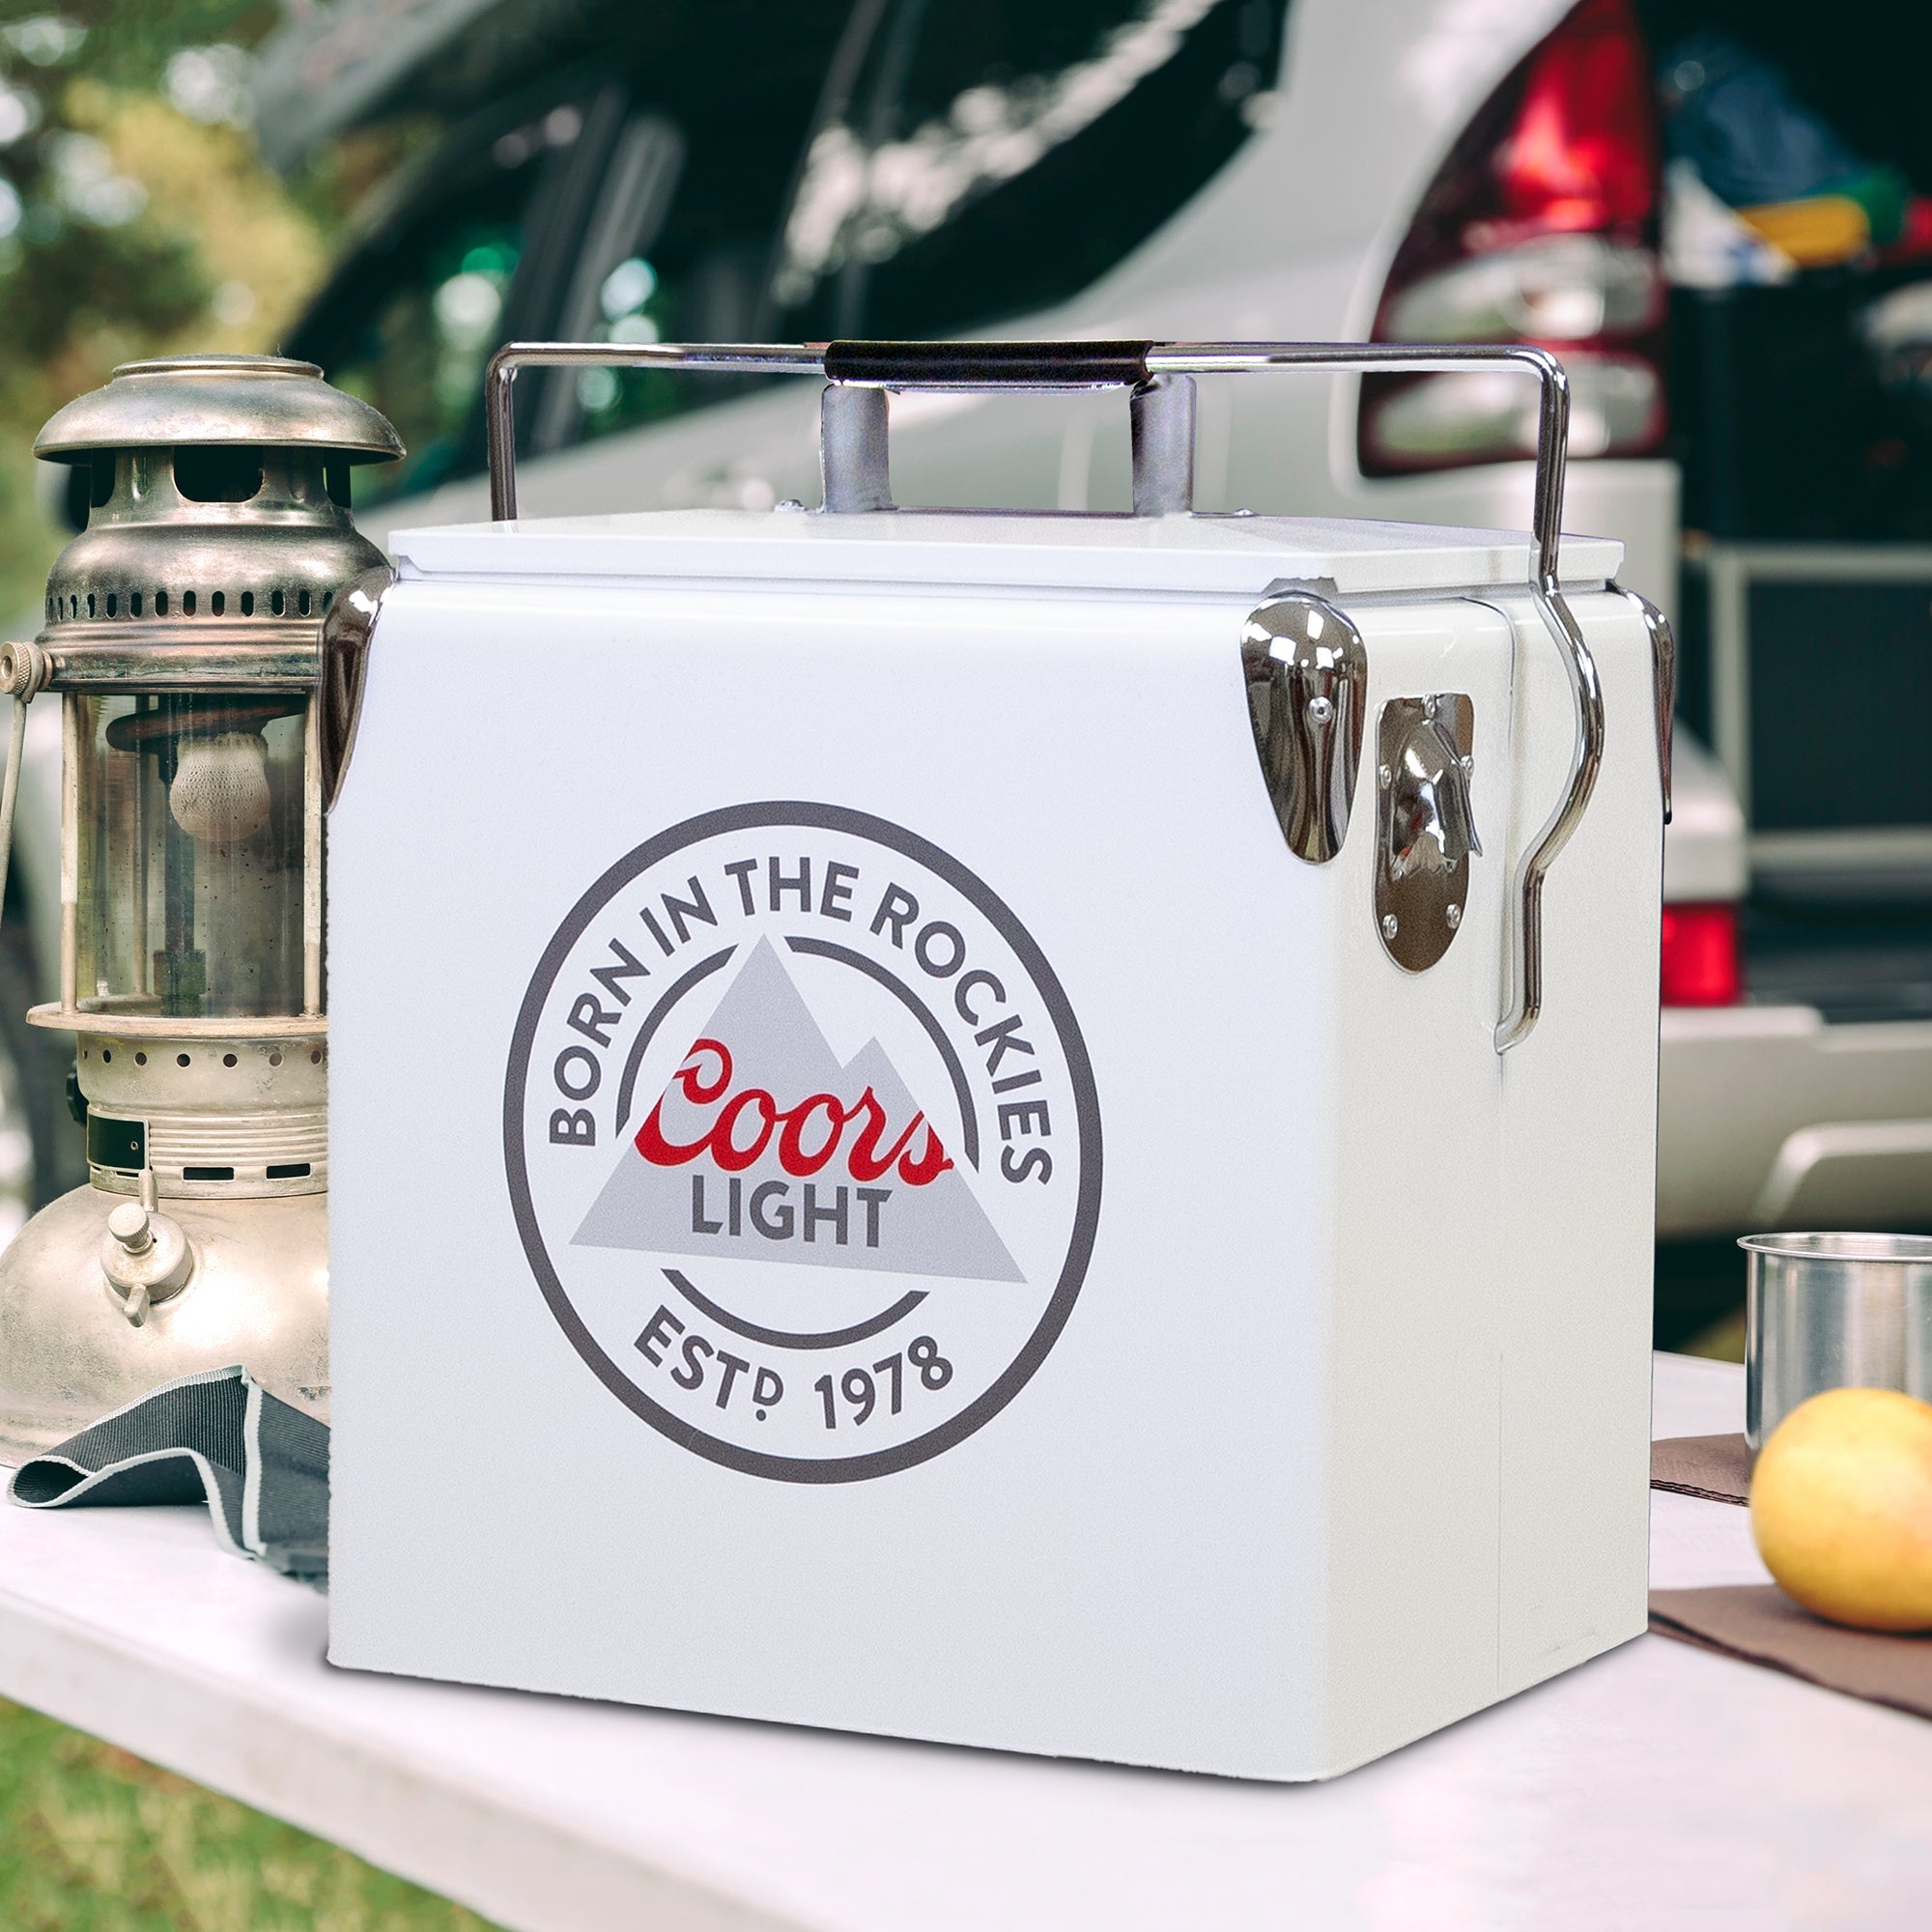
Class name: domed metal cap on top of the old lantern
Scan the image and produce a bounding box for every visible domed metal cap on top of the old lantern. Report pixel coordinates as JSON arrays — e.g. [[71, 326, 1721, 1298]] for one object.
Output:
[[33, 355, 402, 464]]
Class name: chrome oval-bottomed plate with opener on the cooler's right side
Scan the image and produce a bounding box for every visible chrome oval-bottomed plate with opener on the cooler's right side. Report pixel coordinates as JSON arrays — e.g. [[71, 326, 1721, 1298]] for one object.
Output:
[[1376, 692, 1482, 972]]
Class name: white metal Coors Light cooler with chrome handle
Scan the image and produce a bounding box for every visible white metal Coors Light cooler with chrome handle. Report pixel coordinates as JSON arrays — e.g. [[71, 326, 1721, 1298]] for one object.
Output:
[[328, 344, 1669, 1779]]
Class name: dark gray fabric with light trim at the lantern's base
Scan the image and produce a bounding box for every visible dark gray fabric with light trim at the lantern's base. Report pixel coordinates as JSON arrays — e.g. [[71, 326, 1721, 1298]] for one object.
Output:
[[8, 1368, 328, 1588]]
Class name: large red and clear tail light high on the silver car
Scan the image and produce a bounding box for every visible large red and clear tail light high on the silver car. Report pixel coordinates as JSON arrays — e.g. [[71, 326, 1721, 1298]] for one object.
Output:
[[1358, 0, 1665, 475]]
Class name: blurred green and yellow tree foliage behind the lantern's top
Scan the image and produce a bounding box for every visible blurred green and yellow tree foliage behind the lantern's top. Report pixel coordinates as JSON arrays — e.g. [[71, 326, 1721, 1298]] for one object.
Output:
[[0, 0, 325, 612]]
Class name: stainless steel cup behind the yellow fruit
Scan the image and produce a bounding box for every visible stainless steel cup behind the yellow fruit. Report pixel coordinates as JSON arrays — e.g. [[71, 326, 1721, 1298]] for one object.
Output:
[[1739, 1235, 1932, 1449]]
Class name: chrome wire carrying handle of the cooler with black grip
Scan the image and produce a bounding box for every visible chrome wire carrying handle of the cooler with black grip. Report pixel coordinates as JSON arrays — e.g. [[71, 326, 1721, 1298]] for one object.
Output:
[[483, 342, 1604, 1053]]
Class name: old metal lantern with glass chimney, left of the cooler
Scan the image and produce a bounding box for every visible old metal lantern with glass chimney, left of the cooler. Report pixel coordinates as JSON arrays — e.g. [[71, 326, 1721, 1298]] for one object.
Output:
[[0, 355, 402, 1461]]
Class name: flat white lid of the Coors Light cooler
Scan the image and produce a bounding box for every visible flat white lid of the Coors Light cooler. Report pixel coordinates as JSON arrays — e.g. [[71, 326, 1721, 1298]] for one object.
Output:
[[390, 510, 1623, 595]]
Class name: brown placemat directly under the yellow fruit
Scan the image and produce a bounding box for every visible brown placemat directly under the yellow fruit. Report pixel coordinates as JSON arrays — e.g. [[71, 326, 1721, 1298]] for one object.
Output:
[[1650, 1582, 1932, 1718]]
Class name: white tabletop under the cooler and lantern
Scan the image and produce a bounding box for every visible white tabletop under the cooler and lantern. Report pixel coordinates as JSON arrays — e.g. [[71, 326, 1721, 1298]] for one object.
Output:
[[0, 1356, 1932, 1932]]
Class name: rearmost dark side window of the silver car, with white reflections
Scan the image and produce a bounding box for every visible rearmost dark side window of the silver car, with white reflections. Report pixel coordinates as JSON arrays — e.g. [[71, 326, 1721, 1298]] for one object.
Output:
[[773, 0, 1283, 338]]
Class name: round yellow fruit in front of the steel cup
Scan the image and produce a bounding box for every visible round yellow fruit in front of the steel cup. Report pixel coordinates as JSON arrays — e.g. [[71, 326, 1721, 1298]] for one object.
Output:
[[1750, 1389, 1932, 1631]]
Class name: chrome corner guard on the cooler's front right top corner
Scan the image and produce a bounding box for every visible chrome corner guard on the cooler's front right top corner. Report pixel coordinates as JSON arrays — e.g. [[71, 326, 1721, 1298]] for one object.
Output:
[[1240, 591, 1368, 866]]
